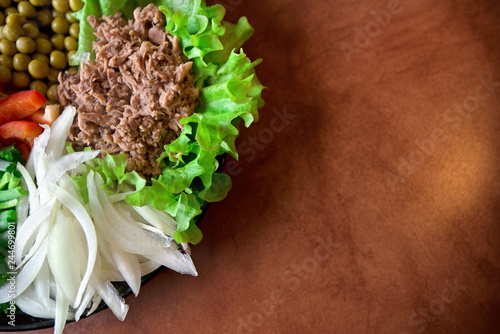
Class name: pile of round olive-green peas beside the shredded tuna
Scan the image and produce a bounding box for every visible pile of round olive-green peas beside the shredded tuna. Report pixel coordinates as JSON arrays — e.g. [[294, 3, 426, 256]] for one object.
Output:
[[0, 0, 83, 101]]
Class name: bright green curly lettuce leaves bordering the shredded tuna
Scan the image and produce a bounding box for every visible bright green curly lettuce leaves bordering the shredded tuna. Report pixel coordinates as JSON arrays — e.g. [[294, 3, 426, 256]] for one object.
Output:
[[74, 0, 264, 244]]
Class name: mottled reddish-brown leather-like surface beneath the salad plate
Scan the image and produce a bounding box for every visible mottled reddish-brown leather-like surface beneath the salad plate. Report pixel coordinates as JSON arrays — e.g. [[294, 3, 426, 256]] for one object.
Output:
[[20, 0, 500, 334]]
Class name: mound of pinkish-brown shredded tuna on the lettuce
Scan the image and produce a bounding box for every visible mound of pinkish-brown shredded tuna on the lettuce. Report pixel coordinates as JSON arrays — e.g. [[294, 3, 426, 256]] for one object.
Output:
[[57, 5, 199, 177]]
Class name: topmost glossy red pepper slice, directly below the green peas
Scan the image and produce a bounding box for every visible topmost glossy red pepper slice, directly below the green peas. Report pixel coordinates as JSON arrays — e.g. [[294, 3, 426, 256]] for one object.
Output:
[[0, 90, 47, 125]]
